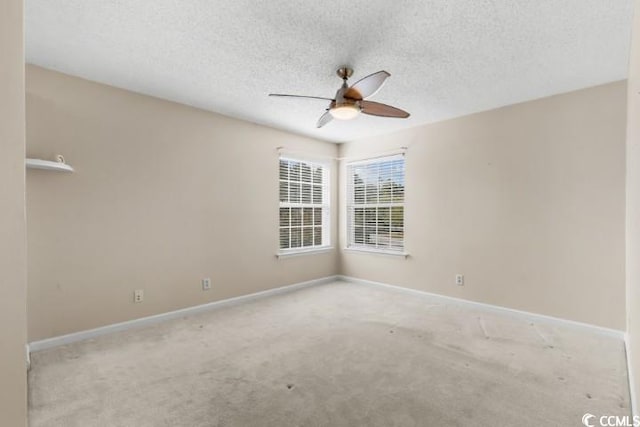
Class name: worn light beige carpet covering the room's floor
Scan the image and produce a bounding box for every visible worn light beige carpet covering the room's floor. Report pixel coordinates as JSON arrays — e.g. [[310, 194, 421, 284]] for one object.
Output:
[[29, 282, 630, 427]]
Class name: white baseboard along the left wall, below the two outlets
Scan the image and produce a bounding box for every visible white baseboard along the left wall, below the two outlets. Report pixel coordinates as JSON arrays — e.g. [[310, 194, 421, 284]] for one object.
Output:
[[27, 276, 338, 352]]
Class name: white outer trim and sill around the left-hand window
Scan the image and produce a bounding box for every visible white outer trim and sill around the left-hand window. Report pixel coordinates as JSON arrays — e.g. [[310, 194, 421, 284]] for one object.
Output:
[[276, 155, 334, 258]]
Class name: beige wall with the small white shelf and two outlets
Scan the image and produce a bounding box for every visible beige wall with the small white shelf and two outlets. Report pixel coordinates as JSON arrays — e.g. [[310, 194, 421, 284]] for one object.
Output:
[[27, 66, 338, 340]]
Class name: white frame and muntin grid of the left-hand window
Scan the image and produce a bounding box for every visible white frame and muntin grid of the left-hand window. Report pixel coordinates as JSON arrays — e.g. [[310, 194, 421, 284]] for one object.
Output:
[[277, 155, 332, 257]]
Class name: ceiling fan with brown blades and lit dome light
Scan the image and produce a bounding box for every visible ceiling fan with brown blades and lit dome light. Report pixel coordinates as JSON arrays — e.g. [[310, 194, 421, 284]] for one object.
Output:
[[269, 67, 409, 128]]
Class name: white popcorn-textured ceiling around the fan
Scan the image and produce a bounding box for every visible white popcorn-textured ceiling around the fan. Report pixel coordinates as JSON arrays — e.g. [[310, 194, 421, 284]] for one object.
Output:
[[25, 0, 632, 142]]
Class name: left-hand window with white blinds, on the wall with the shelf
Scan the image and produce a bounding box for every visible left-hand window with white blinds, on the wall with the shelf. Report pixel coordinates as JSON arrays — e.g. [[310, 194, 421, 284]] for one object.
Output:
[[280, 158, 329, 253]]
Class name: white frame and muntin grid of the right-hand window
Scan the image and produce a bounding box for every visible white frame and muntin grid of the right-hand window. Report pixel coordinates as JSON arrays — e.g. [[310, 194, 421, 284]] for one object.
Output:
[[345, 153, 408, 257]]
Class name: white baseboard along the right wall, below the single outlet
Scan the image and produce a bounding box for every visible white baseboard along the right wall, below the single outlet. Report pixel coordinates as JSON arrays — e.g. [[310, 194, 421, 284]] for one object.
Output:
[[338, 275, 625, 340]]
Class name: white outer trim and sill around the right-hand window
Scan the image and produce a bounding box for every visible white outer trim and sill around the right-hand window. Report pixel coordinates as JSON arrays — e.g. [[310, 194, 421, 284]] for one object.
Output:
[[343, 152, 409, 254]]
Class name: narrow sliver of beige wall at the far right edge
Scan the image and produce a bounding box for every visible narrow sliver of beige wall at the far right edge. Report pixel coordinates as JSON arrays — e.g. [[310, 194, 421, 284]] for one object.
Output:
[[627, 0, 640, 413]]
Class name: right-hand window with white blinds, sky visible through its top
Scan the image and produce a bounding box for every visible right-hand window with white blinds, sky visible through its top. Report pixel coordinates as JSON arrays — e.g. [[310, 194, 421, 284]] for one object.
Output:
[[347, 155, 405, 253]]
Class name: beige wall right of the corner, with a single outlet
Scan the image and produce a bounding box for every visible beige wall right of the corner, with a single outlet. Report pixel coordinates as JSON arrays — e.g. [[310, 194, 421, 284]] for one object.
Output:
[[340, 82, 626, 330]]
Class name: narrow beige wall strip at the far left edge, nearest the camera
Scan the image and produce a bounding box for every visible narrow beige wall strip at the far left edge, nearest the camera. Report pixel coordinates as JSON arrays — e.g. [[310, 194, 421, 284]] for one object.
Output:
[[0, 0, 27, 427]]
